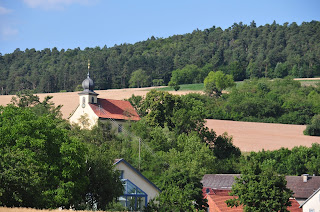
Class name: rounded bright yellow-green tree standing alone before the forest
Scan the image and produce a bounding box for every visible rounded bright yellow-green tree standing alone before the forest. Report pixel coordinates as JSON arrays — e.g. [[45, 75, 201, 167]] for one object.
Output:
[[204, 71, 235, 97]]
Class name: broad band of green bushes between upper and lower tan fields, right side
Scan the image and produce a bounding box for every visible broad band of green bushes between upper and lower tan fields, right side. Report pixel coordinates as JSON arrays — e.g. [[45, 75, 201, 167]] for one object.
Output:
[[199, 78, 320, 124]]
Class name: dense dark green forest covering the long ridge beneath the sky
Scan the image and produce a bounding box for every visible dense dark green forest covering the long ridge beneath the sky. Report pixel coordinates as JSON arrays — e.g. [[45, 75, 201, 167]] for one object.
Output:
[[0, 21, 320, 94]]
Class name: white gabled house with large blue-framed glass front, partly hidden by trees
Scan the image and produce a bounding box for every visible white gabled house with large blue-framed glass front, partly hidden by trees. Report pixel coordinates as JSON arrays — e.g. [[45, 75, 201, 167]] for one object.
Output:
[[114, 159, 161, 211]]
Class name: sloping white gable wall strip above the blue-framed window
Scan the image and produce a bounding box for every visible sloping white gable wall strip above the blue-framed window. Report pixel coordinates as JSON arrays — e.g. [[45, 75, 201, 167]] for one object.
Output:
[[116, 162, 159, 202]]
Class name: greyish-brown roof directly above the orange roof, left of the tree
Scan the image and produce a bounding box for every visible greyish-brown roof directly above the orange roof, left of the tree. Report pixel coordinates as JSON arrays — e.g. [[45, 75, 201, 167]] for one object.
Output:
[[201, 174, 240, 190]]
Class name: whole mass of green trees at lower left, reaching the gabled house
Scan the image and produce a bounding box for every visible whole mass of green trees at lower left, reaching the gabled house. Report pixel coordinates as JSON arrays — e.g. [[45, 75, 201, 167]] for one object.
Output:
[[0, 93, 123, 209]]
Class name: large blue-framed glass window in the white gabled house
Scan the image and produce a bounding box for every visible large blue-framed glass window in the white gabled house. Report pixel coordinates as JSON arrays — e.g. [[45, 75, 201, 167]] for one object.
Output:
[[119, 179, 148, 211]]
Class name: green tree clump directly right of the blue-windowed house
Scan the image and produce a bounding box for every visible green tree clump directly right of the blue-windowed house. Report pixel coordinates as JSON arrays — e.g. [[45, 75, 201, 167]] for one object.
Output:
[[148, 134, 215, 211]]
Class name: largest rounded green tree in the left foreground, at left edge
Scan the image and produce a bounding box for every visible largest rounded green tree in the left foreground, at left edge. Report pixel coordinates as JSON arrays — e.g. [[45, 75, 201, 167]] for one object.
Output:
[[0, 105, 88, 208]]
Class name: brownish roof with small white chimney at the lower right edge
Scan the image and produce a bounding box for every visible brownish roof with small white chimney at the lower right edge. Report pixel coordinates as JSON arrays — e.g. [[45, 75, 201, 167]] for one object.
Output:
[[286, 176, 320, 199]]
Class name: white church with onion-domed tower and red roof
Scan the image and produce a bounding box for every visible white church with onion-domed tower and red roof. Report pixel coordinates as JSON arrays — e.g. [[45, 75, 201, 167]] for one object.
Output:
[[69, 72, 140, 129]]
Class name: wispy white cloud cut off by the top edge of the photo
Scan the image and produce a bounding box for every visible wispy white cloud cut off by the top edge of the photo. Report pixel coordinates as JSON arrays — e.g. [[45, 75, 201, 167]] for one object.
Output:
[[23, 0, 90, 10]]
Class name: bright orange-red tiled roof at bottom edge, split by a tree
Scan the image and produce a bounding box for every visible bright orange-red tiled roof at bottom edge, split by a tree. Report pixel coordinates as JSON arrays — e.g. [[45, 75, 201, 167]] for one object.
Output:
[[205, 189, 302, 212]]
